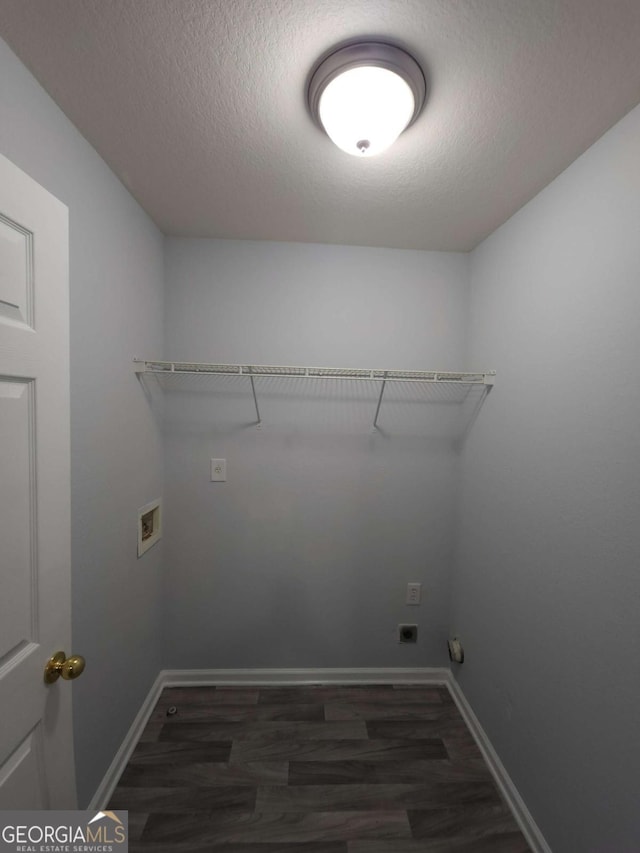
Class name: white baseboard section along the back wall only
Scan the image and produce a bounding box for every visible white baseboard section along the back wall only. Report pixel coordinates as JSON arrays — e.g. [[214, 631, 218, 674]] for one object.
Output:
[[160, 667, 449, 687]]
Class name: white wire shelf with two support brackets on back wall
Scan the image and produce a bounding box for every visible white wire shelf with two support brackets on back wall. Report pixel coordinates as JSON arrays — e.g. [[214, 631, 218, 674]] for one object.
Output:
[[134, 359, 496, 428]]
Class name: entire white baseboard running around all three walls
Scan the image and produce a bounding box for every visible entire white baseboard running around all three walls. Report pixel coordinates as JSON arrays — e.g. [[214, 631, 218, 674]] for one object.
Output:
[[87, 667, 551, 853]]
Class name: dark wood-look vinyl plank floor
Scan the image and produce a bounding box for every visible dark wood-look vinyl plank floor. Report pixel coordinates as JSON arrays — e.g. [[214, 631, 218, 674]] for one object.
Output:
[[109, 685, 530, 853]]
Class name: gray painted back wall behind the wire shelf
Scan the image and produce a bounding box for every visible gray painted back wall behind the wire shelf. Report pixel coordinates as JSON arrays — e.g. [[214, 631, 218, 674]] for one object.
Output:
[[165, 239, 468, 667]]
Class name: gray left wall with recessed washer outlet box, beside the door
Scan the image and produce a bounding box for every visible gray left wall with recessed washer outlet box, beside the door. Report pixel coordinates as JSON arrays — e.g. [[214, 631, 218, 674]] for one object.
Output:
[[0, 41, 163, 805]]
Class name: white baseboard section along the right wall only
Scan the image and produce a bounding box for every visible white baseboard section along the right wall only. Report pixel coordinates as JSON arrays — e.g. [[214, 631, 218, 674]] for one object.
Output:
[[446, 672, 552, 853]]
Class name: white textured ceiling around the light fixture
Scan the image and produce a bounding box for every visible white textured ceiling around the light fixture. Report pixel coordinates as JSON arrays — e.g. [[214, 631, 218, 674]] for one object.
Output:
[[0, 0, 640, 250]]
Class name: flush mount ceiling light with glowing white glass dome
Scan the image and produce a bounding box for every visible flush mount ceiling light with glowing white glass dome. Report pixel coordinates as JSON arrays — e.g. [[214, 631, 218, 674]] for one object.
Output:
[[308, 42, 427, 157]]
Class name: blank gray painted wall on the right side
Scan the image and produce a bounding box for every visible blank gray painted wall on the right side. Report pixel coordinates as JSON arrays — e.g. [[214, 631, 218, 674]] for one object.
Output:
[[453, 103, 640, 853]]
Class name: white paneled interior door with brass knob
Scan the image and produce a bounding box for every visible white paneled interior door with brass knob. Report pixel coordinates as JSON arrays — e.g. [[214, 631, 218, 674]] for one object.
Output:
[[0, 155, 76, 809]]
